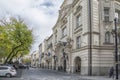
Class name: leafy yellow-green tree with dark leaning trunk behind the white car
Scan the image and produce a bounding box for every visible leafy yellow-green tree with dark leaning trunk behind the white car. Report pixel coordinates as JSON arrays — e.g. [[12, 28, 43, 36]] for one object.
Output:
[[0, 18, 33, 63]]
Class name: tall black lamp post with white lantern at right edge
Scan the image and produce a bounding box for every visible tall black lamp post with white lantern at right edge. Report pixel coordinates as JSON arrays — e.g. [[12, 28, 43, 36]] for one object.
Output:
[[114, 14, 118, 80]]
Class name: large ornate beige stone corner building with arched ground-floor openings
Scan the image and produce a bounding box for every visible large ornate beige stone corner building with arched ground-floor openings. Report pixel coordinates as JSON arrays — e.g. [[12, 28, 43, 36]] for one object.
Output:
[[38, 0, 120, 75]]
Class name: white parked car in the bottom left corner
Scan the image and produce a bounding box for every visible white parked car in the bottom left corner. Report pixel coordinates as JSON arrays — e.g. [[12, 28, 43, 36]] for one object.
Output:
[[0, 66, 17, 77]]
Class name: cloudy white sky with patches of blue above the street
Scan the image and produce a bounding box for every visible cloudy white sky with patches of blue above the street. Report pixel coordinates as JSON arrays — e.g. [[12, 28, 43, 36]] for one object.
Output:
[[0, 0, 63, 52]]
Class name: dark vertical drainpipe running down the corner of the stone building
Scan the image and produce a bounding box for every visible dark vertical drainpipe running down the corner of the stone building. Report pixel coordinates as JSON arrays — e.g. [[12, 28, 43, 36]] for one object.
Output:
[[88, 0, 92, 76]]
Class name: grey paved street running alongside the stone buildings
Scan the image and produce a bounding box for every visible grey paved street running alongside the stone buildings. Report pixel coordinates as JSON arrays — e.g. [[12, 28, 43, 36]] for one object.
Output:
[[0, 68, 89, 80]]
